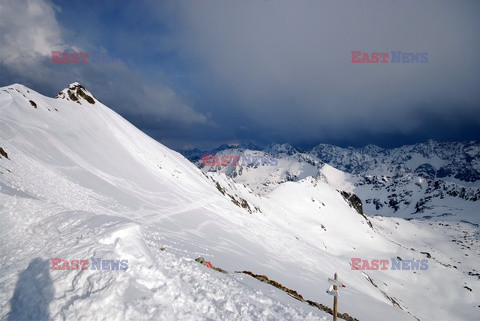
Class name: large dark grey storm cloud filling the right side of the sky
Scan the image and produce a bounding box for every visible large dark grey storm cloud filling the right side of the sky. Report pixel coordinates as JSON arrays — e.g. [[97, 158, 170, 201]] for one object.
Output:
[[173, 1, 480, 143]]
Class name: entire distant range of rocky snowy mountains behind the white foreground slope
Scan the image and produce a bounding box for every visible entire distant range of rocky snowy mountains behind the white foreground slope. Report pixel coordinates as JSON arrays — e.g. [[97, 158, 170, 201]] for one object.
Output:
[[189, 141, 480, 224]]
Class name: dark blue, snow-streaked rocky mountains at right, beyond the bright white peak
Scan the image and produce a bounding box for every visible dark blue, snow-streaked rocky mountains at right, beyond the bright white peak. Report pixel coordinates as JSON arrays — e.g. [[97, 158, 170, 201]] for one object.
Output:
[[310, 140, 480, 224]]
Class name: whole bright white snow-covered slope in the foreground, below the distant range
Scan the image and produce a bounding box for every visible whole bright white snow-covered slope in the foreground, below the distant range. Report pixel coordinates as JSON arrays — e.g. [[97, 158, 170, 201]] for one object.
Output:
[[0, 84, 480, 320]]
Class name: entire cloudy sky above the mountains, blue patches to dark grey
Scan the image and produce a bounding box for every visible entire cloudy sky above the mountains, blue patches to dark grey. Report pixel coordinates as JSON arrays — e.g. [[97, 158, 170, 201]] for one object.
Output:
[[0, 0, 480, 149]]
